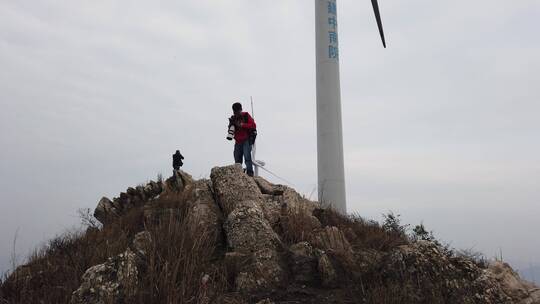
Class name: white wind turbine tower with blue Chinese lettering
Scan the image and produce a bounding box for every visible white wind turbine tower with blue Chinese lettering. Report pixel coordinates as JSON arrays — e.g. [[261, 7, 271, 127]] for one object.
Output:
[[315, 0, 347, 213]]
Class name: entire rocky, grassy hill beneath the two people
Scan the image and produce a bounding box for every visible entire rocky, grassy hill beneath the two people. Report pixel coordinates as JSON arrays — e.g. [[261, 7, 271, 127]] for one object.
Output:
[[0, 165, 540, 304]]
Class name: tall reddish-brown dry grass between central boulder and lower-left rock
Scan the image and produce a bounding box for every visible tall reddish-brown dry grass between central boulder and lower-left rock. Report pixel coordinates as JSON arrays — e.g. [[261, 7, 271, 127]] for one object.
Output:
[[134, 205, 227, 303]]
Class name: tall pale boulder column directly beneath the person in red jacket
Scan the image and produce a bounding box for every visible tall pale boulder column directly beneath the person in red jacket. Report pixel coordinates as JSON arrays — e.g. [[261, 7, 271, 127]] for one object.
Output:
[[210, 165, 285, 292]]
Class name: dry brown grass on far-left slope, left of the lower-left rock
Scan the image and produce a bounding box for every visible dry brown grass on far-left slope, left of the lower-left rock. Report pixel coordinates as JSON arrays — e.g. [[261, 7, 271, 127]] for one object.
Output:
[[1, 209, 142, 304]]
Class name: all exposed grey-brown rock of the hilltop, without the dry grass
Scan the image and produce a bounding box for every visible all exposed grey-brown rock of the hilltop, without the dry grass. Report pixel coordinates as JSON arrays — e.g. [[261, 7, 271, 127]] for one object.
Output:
[[57, 165, 540, 304]]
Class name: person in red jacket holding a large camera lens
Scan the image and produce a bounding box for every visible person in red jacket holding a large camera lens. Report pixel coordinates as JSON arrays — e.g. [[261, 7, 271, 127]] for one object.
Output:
[[230, 102, 257, 176]]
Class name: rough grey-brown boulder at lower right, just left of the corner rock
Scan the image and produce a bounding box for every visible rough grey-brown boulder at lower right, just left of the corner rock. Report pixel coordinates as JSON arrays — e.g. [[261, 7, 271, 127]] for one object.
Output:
[[378, 241, 516, 304]]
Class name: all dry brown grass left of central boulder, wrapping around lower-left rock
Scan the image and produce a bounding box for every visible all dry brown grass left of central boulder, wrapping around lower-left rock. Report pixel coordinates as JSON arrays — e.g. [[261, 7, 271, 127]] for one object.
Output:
[[0, 182, 227, 304]]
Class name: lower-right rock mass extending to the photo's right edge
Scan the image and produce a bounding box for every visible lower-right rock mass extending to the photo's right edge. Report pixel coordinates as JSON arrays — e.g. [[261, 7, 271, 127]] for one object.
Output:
[[380, 241, 540, 304]]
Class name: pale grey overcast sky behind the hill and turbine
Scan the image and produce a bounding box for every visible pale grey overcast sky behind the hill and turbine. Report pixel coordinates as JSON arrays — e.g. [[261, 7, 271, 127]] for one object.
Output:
[[0, 0, 540, 271]]
